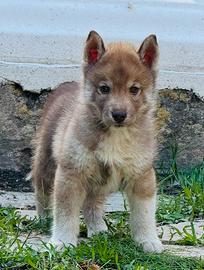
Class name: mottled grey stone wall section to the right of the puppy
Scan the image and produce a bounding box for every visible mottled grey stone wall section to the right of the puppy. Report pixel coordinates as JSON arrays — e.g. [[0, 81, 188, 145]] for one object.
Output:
[[156, 89, 204, 173]]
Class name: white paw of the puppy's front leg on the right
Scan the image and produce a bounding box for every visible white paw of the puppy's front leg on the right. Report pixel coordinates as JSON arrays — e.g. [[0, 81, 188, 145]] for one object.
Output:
[[136, 238, 164, 253]]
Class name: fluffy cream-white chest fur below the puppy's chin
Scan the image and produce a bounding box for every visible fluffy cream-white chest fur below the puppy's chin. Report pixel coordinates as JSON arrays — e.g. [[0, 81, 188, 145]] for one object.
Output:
[[95, 128, 151, 180]]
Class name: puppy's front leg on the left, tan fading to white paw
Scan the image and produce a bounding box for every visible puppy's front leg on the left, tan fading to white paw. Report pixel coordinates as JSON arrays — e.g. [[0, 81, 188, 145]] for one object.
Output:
[[51, 166, 85, 246]]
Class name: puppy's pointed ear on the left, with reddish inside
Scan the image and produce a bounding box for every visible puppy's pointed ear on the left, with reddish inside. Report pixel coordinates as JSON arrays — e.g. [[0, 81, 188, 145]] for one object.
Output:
[[84, 31, 105, 65]]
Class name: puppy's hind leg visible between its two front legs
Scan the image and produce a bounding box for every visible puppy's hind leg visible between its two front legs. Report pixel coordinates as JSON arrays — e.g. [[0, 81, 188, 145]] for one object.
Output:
[[83, 193, 107, 237]]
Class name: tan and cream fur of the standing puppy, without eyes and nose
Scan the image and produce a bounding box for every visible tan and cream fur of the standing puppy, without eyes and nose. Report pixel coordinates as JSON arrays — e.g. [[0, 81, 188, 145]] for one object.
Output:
[[32, 31, 162, 252]]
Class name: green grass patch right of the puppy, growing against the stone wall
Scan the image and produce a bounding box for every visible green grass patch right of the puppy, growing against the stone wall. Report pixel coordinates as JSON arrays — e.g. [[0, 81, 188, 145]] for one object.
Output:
[[157, 161, 204, 224]]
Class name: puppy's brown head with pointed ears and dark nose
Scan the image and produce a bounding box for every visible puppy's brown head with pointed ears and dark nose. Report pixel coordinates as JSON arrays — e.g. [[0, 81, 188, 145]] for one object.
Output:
[[84, 31, 159, 127]]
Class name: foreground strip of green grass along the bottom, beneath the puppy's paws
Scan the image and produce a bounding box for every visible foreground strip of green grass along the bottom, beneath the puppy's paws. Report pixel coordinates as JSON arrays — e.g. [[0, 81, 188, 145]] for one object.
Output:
[[0, 209, 204, 270]]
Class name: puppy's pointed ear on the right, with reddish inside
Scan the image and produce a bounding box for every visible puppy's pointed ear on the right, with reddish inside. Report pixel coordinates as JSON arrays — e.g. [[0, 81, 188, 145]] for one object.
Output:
[[138, 35, 159, 71]]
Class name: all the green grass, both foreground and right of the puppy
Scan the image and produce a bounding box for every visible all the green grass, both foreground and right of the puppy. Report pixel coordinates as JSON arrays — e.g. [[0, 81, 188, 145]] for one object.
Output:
[[0, 158, 204, 270]]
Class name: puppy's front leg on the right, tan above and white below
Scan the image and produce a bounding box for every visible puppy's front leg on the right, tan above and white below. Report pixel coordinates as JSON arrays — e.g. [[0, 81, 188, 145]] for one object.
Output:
[[127, 169, 163, 253]]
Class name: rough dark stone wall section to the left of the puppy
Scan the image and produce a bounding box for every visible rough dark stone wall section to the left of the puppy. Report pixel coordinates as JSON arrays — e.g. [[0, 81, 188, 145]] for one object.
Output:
[[0, 84, 48, 191]]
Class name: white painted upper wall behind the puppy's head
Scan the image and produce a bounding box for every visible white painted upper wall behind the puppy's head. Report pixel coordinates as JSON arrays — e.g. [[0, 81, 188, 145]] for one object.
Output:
[[0, 0, 204, 96]]
